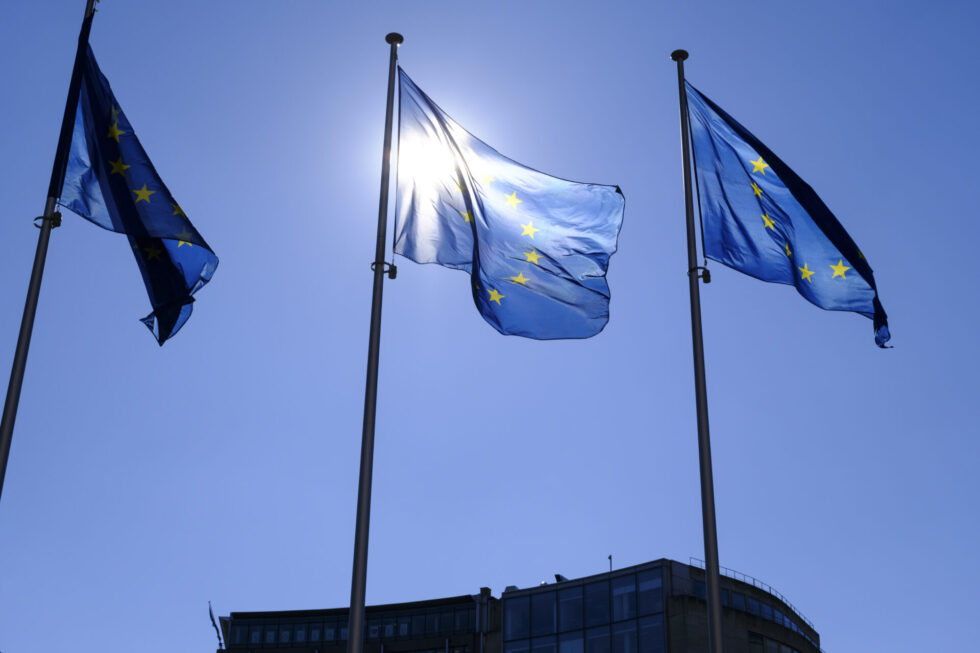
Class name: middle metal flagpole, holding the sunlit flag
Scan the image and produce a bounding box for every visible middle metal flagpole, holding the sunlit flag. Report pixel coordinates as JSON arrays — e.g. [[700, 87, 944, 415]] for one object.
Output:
[[347, 32, 404, 653]]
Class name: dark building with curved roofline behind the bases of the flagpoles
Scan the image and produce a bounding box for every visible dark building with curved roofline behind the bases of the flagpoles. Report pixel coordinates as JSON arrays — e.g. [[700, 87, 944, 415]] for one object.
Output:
[[221, 559, 820, 653]]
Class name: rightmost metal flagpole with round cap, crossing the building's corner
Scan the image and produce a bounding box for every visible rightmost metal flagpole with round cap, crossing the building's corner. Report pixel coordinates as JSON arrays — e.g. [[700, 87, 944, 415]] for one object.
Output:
[[670, 50, 722, 653]]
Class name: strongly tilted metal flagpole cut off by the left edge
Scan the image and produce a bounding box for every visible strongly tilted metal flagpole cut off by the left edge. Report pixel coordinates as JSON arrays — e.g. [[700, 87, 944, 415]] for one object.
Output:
[[0, 0, 97, 504]]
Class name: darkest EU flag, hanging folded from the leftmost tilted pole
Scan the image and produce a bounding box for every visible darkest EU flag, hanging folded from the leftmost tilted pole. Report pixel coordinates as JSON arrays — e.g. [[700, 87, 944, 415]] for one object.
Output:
[[58, 47, 218, 345]]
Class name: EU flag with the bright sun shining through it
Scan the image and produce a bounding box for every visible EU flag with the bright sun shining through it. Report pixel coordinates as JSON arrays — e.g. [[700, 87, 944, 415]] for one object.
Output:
[[395, 69, 625, 340]]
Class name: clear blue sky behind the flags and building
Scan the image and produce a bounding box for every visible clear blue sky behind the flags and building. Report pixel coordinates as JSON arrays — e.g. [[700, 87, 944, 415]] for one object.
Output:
[[0, 0, 980, 653]]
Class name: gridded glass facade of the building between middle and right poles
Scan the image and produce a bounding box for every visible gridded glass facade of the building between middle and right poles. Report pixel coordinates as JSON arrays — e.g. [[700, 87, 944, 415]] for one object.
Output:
[[502, 566, 666, 653]]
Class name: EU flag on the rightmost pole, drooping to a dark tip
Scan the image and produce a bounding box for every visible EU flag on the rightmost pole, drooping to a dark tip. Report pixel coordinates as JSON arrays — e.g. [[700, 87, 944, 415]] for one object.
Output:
[[687, 84, 891, 347]]
